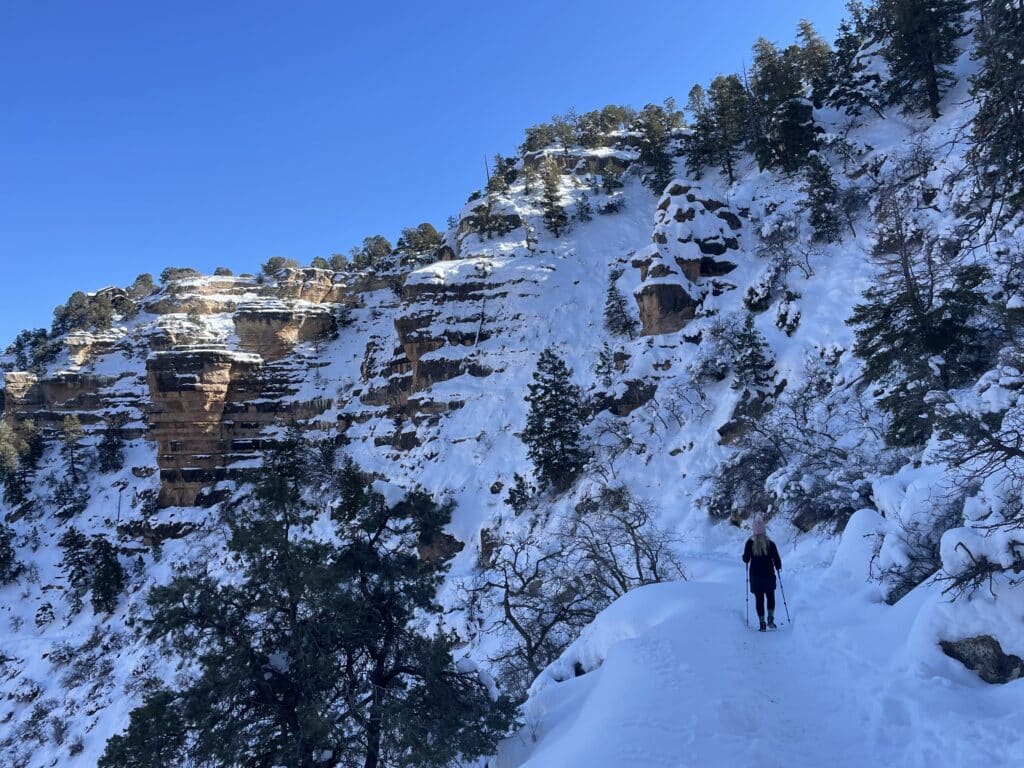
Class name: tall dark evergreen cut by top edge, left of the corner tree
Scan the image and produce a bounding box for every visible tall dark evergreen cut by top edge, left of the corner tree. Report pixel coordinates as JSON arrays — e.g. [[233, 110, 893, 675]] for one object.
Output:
[[873, 0, 962, 119]]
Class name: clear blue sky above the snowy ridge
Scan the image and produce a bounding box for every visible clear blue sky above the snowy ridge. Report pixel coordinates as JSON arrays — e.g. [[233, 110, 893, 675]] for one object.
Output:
[[0, 0, 843, 346]]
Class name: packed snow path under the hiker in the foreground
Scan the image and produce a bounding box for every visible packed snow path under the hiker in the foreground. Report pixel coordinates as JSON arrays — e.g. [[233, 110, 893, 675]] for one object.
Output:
[[498, 540, 1024, 768]]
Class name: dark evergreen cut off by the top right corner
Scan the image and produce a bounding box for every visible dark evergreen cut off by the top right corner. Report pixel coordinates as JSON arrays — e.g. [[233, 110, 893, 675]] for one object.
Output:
[[971, 0, 1024, 220]]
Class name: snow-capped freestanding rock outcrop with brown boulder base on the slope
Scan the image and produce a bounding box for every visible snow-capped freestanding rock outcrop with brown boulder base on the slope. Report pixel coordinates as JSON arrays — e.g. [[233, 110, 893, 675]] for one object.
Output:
[[631, 181, 746, 336]]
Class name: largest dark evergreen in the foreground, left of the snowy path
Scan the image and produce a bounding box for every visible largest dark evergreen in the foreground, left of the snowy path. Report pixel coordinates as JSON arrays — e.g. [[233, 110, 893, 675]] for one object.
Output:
[[98, 438, 513, 768]]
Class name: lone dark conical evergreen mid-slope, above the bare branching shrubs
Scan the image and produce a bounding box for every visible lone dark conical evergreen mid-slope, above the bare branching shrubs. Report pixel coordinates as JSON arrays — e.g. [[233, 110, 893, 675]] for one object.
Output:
[[522, 347, 587, 490]]
